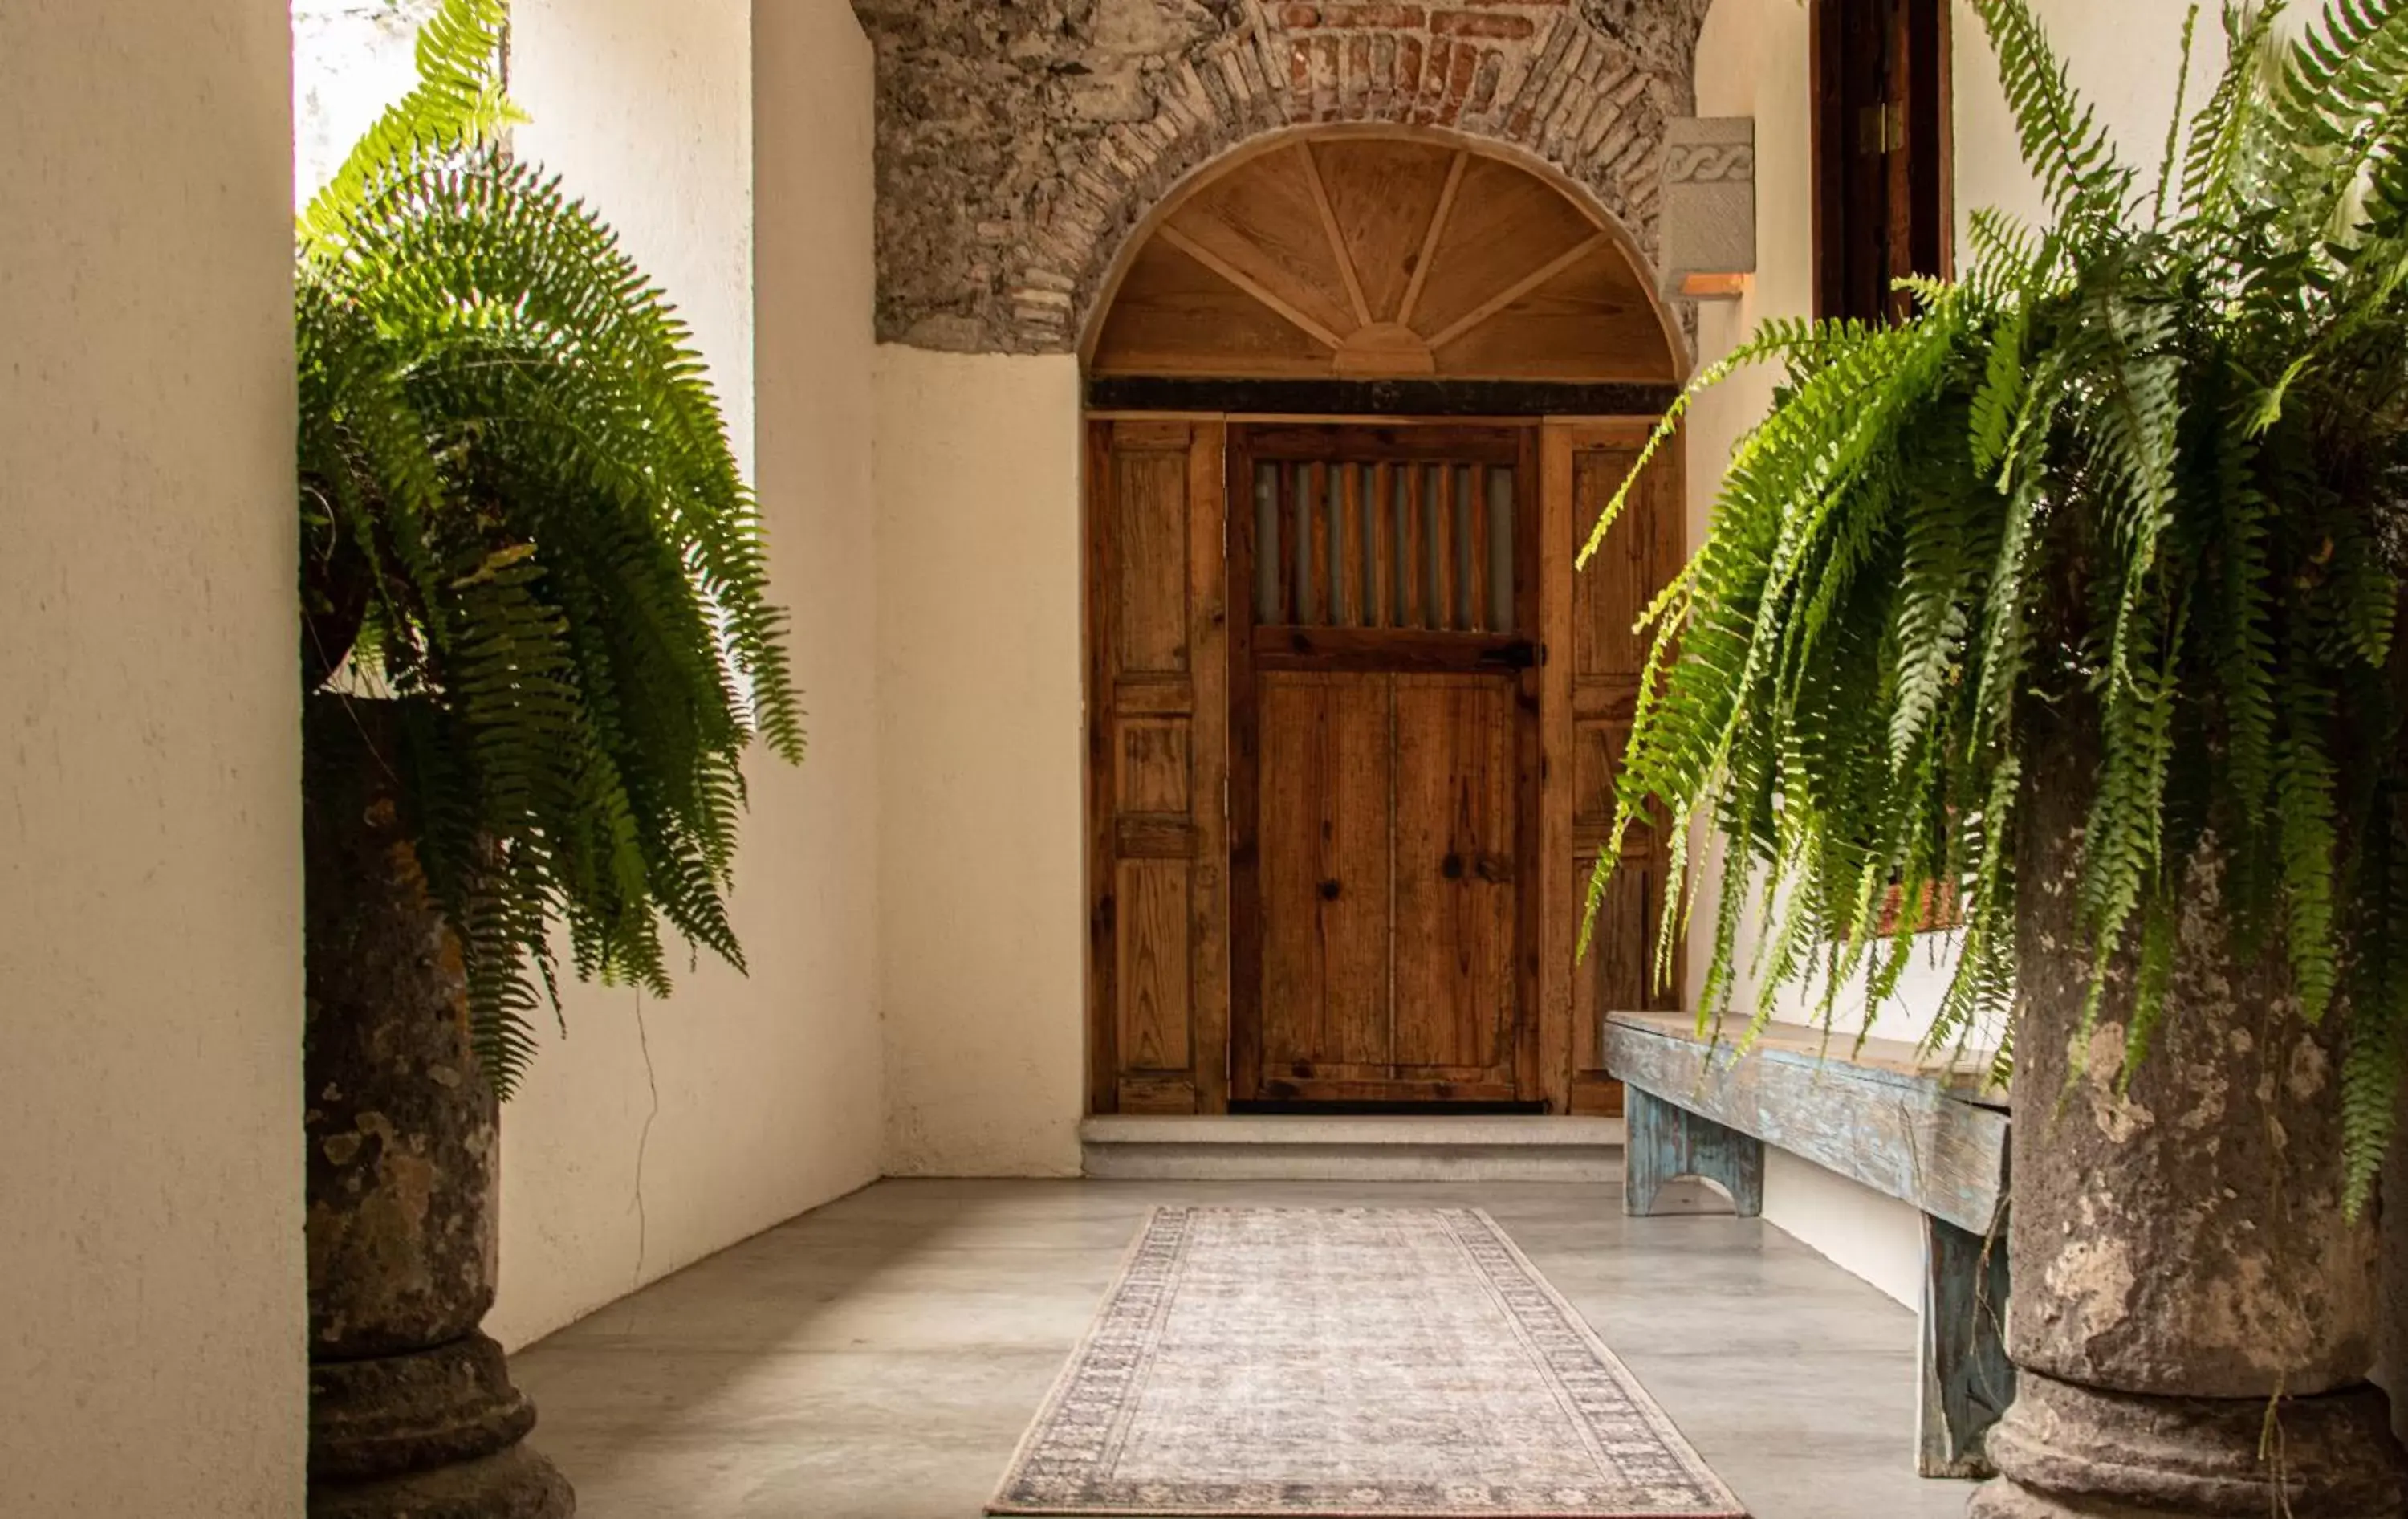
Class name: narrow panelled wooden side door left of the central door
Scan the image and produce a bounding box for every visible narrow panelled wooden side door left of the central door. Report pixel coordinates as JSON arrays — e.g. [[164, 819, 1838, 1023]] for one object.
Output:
[[1086, 421, 1228, 1112]]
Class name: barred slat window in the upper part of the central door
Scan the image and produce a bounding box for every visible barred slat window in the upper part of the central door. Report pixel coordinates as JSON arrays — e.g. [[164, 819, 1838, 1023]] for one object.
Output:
[[1255, 460, 1517, 633]]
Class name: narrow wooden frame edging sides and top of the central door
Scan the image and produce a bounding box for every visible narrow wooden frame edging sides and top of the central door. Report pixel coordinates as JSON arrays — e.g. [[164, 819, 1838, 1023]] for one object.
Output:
[[1223, 417, 1546, 1100]]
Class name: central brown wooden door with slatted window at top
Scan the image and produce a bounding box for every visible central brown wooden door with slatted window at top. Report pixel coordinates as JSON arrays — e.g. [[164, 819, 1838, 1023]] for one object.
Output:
[[1230, 426, 1541, 1102]]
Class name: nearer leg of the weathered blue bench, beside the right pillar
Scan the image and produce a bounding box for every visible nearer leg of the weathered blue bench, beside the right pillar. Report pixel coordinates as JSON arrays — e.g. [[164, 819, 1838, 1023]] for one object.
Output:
[[1914, 1213, 2015, 1478]]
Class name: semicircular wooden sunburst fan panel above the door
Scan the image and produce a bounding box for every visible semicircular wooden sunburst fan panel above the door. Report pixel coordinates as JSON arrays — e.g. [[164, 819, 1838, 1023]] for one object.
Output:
[[1088, 135, 1676, 383]]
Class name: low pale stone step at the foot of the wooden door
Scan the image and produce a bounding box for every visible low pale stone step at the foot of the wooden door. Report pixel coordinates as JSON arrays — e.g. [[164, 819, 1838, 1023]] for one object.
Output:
[[1079, 1114, 1623, 1182]]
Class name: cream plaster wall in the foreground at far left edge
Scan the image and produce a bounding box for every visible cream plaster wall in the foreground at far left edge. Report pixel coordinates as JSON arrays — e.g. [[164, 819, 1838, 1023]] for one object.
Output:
[[0, 0, 306, 1519]]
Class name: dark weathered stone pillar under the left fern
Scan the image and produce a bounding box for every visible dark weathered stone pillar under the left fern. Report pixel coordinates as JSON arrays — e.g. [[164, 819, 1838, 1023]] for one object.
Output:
[[303, 696, 576, 1519]]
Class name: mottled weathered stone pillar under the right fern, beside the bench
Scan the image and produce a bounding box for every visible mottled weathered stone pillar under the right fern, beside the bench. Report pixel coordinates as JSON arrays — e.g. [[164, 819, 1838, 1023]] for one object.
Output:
[[1970, 744, 2408, 1519]]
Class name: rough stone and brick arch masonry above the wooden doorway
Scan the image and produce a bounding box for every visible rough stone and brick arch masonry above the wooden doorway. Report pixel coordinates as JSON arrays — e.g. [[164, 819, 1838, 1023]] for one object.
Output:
[[855, 0, 1712, 354]]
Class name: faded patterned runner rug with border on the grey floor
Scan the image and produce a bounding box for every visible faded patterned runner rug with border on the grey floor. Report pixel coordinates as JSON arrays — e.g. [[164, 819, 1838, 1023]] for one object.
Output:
[[987, 1208, 1746, 1519]]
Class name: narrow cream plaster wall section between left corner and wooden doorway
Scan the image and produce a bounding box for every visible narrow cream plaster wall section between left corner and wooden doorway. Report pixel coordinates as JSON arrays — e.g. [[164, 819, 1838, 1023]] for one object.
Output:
[[877, 347, 1086, 1175]]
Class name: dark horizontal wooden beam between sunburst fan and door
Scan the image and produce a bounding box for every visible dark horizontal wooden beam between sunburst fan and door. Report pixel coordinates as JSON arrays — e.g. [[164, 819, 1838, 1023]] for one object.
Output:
[[1086, 376, 1681, 417]]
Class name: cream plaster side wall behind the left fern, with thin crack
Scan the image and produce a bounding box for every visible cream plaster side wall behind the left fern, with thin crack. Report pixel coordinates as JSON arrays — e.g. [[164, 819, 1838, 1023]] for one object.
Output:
[[486, 0, 884, 1346]]
